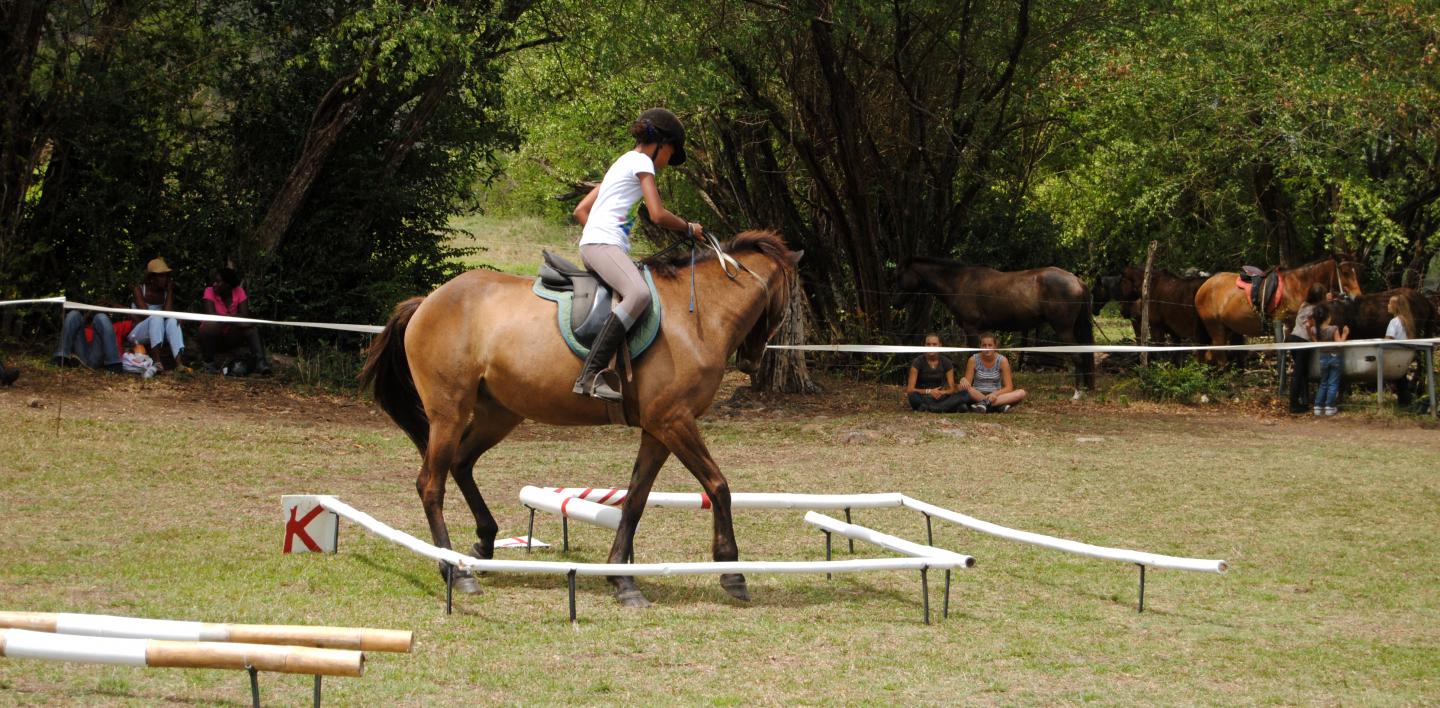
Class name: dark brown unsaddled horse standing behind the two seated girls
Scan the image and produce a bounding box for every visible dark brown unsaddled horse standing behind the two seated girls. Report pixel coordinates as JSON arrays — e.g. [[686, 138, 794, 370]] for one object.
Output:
[[896, 258, 1094, 394]]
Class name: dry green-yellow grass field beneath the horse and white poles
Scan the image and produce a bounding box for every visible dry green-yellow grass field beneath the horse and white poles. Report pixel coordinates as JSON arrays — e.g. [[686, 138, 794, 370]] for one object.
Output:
[[0, 368, 1440, 705]]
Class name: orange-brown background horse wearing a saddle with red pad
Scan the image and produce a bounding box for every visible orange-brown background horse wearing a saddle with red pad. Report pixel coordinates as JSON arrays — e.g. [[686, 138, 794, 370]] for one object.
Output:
[[1195, 256, 1359, 364]]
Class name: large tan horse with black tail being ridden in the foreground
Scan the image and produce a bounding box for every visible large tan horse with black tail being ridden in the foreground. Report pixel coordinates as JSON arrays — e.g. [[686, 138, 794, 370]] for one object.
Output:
[[361, 232, 804, 607]]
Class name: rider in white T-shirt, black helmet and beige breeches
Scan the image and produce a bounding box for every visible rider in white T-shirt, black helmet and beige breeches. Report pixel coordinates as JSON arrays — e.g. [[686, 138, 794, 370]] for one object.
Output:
[[575, 108, 703, 401]]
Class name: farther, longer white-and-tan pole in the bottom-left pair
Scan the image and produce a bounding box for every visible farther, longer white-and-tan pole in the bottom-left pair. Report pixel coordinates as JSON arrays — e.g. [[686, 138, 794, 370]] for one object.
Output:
[[0, 610, 415, 652]]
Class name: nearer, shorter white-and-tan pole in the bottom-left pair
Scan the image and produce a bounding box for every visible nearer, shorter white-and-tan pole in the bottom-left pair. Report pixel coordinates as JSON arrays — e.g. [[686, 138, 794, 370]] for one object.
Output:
[[0, 629, 364, 676]]
